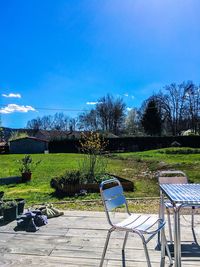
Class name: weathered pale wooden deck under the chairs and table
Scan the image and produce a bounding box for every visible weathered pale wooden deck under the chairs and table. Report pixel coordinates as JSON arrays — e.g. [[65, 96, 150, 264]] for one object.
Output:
[[0, 211, 200, 267]]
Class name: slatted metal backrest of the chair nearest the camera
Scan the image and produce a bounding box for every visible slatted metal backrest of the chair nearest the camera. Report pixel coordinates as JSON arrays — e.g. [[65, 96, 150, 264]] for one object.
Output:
[[100, 178, 129, 225]]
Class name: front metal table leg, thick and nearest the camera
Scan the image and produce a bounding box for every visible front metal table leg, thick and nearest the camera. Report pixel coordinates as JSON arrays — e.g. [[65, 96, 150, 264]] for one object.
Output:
[[174, 206, 181, 267]]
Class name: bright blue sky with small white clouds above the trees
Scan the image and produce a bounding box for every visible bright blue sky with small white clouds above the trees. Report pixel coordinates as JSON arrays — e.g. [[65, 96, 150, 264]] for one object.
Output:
[[0, 0, 200, 128]]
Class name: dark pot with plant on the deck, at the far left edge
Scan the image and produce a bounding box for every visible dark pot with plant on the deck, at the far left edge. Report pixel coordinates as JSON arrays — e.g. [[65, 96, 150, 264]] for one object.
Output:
[[1, 200, 18, 222]]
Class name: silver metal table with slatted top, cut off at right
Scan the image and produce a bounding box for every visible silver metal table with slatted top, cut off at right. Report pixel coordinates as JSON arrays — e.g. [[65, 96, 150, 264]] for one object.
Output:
[[160, 184, 200, 267]]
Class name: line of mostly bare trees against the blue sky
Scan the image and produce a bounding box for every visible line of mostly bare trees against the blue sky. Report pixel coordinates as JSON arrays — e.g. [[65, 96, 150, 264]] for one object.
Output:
[[27, 81, 200, 136]]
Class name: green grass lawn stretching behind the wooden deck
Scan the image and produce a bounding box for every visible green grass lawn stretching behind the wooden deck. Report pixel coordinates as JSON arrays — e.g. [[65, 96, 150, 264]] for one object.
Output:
[[0, 148, 200, 209]]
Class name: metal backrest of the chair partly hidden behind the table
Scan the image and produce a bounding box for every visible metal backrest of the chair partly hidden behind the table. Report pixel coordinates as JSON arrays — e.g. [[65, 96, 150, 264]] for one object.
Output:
[[157, 170, 188, 184]]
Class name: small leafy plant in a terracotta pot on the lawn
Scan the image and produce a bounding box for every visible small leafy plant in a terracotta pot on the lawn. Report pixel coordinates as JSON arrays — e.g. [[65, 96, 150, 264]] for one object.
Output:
[[18, 155, 40, 182]]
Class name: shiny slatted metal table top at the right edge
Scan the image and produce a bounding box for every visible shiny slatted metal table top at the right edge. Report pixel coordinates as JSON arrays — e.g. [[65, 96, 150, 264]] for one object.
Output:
[[160, 184, 200, 205]]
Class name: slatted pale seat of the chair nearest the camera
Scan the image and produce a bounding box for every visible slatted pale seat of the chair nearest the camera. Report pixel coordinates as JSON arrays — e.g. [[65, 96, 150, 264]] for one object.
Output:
[[114, 214, 164, 234]]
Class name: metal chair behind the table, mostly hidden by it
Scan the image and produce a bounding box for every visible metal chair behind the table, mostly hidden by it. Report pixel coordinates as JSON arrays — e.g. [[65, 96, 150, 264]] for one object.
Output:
[[157, 170, 194, 243]]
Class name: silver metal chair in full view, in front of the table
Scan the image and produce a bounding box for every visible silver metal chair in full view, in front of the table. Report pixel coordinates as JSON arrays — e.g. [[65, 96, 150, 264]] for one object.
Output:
[[99, 178, 172, 267]]
